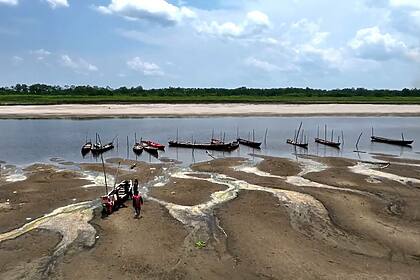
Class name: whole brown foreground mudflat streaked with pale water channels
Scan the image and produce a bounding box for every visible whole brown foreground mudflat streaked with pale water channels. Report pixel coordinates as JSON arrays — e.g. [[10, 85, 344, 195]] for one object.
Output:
[[0, 155, 420, 280]]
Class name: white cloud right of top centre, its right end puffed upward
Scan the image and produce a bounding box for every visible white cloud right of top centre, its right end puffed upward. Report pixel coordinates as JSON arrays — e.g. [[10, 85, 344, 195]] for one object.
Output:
[[196, 11, 270, 39]]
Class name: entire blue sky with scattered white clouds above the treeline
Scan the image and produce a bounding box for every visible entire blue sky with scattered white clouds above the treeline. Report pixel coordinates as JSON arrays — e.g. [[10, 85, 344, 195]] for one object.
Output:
[[0, 0, 420, 89]]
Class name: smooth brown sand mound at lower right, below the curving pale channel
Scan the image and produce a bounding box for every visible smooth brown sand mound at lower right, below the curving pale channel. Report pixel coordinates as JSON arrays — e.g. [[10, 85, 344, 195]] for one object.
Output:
[[216, 189, 420, 280]]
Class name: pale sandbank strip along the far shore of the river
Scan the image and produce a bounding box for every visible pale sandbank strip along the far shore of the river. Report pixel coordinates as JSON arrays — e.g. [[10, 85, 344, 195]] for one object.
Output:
[[0, 104, 420, 119]]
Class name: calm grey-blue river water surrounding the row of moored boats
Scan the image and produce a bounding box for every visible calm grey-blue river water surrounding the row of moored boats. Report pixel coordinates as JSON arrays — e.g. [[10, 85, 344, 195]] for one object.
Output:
[[0, 117, 420, 164]]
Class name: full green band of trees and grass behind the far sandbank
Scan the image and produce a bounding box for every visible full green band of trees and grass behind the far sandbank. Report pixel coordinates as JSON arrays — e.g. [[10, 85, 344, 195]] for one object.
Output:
[[0, 84, 420, 105]]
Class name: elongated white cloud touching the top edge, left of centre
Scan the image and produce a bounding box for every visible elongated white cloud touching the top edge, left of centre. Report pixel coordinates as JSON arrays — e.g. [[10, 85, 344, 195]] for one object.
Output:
[[97, 0, 196, 25]]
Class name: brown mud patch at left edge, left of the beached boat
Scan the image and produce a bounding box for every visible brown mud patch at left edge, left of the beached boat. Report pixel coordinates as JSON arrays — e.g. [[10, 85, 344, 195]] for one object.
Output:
[[0, 164, 97, 233]]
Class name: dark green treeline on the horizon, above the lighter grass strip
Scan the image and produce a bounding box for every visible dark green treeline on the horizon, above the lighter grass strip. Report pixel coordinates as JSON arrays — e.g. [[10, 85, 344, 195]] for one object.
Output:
[[0, 84, 420, 97]]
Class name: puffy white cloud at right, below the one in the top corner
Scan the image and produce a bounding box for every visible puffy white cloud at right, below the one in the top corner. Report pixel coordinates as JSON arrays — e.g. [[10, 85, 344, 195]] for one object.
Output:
[[349, 26, 408, 60]]
